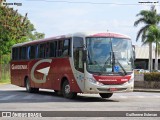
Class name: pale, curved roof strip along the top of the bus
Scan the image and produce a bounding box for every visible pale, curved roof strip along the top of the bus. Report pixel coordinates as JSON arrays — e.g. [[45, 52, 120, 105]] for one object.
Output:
[[13, 32, 131, 47]]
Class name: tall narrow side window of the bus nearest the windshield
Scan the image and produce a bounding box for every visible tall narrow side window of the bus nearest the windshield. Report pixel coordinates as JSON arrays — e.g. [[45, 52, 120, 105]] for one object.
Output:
[[73, 37, 84, 72]]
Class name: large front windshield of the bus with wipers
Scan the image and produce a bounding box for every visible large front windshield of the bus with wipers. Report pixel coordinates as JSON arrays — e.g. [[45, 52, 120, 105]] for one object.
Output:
[[86, 37, 133, 74]]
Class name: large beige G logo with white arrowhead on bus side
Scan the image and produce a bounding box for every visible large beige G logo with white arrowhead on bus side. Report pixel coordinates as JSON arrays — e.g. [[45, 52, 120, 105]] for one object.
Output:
[[31, 59, 52, 83]]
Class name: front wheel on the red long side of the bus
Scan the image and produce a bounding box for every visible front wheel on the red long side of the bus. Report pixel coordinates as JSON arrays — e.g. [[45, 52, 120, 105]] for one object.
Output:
[[62, 80, 77, 99]]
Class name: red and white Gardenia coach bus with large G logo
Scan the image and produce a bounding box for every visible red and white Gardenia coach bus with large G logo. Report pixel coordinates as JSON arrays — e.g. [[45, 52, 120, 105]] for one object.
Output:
[[10, 32, 134, 99]]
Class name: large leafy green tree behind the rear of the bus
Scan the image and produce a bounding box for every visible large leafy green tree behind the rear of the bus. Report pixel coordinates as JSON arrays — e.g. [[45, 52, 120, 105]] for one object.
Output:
[[0, 0, 45, 79]]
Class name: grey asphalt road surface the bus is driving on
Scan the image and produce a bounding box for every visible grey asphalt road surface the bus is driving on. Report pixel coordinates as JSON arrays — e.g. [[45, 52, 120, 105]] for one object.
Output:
[[0, 84, 160, 120]]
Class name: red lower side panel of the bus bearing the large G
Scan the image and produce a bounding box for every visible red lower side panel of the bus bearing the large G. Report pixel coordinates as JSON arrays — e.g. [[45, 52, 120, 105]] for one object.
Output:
[[14, 58, 81, 92]]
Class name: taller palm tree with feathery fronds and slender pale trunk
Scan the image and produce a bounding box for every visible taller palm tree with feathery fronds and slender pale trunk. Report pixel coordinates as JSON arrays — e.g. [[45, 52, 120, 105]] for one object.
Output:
[[134, 6, 160, 72]]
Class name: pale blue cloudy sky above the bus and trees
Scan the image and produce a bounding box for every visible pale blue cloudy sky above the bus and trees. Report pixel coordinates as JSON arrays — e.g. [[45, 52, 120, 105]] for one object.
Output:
[[2, 0, 160, 46]]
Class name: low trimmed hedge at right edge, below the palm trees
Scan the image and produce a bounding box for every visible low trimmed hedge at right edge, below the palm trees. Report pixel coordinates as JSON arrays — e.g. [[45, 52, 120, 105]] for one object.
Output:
[[144, 72, 160, 82]]
